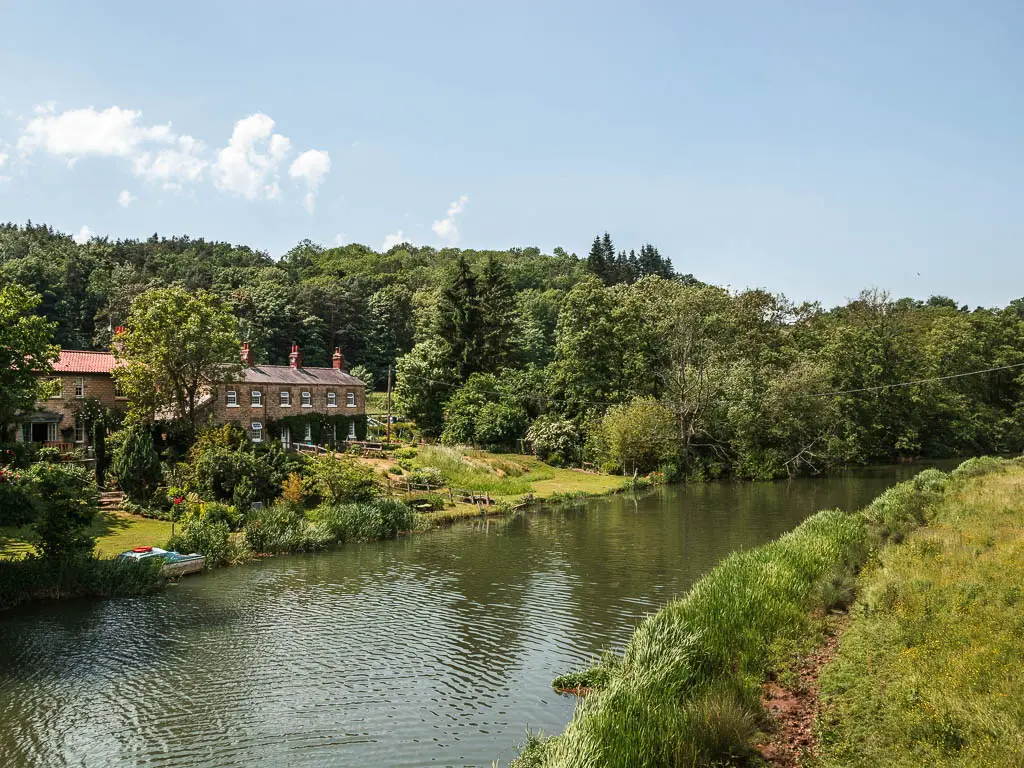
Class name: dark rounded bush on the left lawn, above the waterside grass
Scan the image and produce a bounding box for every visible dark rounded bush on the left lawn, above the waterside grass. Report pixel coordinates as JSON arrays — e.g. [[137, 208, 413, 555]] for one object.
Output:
[[20, 462, 99, 558]]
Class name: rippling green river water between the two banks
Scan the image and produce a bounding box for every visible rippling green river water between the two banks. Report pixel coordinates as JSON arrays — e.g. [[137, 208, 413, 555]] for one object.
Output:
[[0, 467, 920, 768]]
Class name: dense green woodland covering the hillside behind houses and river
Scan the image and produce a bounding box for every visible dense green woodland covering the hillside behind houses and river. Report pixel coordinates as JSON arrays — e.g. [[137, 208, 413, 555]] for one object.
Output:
[[0, 219, 1024, 477]]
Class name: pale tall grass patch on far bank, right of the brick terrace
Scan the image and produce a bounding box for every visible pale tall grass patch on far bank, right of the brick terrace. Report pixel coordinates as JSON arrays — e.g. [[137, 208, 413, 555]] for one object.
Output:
[[416, 445, 553, 496]]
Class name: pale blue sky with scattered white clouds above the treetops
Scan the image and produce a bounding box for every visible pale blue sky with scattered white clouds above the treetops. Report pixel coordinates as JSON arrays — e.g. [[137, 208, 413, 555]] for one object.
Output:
[[0, 0, 1024, 305]]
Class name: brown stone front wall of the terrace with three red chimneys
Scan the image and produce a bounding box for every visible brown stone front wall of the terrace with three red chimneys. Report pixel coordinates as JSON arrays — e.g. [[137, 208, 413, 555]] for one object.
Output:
[[213, 384, 367, 440]]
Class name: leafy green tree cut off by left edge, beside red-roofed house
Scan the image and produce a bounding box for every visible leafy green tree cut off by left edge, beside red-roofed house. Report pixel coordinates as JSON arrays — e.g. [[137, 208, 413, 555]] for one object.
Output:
[[0, 281, 58, 438]]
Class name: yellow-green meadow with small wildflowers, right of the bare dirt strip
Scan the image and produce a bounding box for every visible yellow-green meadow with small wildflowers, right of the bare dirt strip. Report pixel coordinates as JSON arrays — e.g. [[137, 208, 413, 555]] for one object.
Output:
[[816, 466, 1024, 768]]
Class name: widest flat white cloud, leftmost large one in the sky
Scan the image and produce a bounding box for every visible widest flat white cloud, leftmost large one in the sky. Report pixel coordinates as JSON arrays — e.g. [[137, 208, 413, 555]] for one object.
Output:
[[17, 103, 174, 159]]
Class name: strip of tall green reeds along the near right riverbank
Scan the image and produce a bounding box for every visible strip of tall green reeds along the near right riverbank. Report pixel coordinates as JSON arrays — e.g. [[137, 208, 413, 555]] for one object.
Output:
[[514, 460, 966, 768]]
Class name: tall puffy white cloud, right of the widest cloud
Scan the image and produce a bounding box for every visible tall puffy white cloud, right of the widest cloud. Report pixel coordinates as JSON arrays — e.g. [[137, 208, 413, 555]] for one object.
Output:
[[213, 113, 292, 200]]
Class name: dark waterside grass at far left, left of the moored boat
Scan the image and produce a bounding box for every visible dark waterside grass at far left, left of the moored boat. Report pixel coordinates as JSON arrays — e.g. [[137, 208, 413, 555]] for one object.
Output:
[[0, 555, 167, 610]]
